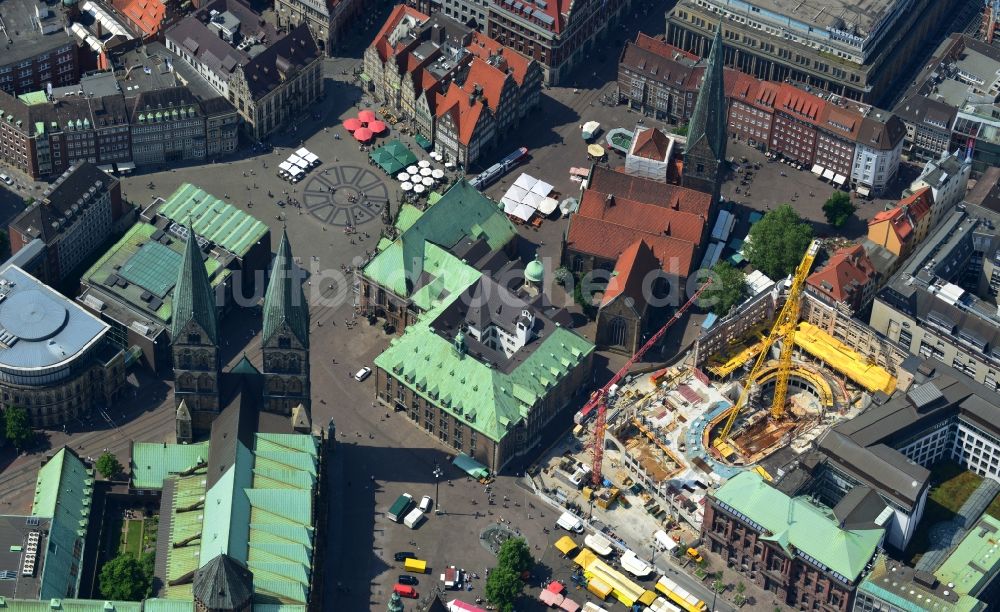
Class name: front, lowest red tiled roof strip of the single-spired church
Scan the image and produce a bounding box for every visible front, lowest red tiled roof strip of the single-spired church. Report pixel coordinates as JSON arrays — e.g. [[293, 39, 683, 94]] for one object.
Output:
[[566, 215, 695, 277]]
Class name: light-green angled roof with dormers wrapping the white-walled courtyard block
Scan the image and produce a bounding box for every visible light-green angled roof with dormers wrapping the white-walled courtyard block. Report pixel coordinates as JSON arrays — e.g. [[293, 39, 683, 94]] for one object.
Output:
[[375, 296, 594, 441]]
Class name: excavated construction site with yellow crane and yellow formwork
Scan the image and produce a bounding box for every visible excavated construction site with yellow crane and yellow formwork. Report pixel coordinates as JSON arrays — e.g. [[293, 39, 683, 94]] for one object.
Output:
[[546, 242, 896, 537]]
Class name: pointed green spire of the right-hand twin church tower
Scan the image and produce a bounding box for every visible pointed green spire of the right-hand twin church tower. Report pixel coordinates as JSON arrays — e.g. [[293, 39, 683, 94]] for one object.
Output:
[[261, 229, 309, 347]]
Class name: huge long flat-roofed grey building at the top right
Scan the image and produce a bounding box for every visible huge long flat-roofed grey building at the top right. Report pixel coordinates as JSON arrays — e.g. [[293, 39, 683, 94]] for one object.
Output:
[[667, 0, 958, 104]]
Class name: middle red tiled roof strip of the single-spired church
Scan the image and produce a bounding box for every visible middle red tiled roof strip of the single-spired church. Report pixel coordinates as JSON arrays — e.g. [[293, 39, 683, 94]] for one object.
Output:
[[577, 189, 705, 244]]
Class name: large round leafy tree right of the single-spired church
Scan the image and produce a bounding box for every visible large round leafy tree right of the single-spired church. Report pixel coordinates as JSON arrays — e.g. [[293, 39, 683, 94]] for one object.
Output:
[[746, 204, 812, 280]]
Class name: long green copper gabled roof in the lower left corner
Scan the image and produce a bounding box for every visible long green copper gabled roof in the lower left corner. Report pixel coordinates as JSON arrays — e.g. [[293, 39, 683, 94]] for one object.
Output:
[[31, 448, 94, 599]]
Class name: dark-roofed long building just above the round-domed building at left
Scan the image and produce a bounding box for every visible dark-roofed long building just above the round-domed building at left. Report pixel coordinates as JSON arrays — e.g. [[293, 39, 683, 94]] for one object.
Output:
[[7, 162, 126, 284]]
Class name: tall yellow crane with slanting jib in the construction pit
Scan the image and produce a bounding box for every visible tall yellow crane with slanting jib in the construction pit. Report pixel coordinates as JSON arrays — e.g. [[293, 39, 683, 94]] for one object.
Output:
[[714, 240, 819, 447]]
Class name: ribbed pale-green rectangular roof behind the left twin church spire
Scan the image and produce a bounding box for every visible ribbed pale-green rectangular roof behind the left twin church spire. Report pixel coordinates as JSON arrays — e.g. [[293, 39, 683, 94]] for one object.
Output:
[[157, 183, 268, 257]]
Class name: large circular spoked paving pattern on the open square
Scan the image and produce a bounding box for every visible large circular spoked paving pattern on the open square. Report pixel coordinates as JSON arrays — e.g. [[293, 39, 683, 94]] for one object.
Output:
[[302, 166, 389, 227]]
